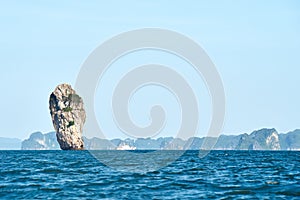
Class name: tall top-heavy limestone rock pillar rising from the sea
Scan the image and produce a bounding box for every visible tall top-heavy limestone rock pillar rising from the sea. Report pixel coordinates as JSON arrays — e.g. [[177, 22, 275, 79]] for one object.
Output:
[[49, 84, 86, 150]]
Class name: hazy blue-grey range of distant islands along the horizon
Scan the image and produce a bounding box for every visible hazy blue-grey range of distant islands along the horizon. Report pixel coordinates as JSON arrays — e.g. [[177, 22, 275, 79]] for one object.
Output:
[[0, 129, 300, 151]]
